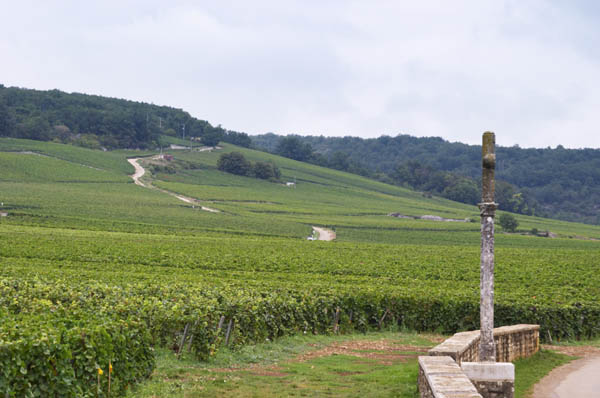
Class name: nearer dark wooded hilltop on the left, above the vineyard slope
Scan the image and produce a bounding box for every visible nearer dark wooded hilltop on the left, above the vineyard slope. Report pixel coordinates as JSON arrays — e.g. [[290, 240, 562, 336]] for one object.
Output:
[[0, 84, 250, 149]]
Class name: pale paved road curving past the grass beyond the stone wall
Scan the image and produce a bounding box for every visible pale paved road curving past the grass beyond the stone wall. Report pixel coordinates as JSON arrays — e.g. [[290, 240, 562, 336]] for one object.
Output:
[[533, 349, 600, 398]]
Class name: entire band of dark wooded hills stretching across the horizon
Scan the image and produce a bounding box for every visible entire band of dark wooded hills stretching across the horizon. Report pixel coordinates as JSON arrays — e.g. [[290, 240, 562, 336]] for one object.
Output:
[[0, 84, 600, 224]]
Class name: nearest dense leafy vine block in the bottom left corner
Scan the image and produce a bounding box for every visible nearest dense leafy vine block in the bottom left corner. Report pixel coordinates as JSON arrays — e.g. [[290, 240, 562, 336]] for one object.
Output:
[[0, 312, 154, 398]]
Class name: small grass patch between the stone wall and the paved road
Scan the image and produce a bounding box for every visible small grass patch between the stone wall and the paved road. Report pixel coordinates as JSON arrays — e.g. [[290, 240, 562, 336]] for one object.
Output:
[[514, 350, 576, 398]]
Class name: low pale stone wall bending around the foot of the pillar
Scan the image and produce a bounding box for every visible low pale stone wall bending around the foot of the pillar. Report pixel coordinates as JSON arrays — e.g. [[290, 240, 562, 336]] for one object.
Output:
[[418, 325, 540, 398]]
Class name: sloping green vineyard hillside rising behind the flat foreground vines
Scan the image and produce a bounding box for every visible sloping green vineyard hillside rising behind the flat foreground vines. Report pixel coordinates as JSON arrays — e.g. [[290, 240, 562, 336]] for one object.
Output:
[[0, 138, 600, 244]]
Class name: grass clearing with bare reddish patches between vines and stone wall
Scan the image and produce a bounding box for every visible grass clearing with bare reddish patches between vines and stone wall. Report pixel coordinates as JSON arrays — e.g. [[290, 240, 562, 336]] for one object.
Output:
[[130, 332, 440, 398]]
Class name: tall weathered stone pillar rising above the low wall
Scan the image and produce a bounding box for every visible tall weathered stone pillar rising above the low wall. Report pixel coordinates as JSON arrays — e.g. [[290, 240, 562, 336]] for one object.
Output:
[[479, 131, 498, 362]]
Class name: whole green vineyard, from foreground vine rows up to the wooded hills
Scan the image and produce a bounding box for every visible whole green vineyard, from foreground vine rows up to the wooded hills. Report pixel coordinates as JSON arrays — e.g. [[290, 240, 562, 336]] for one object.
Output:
[[0, 139, 600, 397]]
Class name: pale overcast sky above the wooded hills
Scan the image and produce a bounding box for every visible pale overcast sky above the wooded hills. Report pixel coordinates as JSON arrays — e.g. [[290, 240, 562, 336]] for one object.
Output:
[[0, 0, 600, 148]]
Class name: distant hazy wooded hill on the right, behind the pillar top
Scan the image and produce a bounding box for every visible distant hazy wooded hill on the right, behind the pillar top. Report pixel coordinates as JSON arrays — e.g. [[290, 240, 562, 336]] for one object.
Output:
[[252, 134, 600, 224]]
